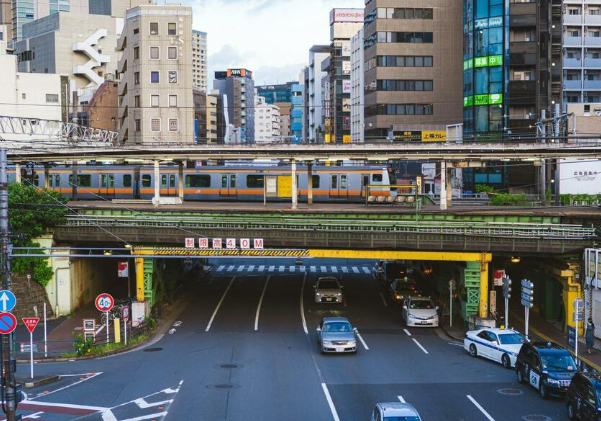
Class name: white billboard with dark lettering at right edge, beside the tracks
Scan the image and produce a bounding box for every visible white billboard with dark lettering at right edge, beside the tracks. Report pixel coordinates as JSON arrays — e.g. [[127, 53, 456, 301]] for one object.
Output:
[[559, 159, 601, 194]]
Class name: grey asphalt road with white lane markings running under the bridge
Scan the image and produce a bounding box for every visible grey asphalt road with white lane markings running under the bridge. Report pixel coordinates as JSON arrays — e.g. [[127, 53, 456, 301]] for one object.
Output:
[[10, 261, 567, 421]]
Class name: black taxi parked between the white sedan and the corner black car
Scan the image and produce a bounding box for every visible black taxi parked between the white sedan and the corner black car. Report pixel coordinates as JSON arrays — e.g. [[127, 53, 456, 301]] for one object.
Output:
[[515, 342, 577, 399]]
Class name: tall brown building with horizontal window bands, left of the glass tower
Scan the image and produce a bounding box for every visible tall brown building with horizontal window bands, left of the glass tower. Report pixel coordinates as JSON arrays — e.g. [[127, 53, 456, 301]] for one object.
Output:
[[364, 0, 464, 140]]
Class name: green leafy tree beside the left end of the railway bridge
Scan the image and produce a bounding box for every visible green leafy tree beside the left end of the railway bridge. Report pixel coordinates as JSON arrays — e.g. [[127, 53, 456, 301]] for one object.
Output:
[[8, 183, 66, 286]]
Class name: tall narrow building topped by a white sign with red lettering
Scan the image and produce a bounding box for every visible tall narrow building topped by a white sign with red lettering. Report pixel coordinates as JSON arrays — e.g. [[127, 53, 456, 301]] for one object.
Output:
[[322, 9, 364, 143]]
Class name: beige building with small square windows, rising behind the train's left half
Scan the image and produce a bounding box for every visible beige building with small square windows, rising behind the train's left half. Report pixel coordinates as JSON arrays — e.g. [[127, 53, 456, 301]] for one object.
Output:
[[117, 5, 195, 144]]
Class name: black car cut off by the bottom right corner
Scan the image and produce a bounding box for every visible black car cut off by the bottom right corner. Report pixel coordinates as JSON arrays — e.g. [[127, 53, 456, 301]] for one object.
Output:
[[566, 372, 601, 421]]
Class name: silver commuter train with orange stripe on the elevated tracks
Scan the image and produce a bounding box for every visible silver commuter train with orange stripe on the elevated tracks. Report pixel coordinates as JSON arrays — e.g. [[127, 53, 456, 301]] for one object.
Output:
[[8, 164, 395, 202]]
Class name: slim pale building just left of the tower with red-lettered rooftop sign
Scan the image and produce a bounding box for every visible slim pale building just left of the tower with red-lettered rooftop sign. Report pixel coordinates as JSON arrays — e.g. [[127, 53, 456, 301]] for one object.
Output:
[[303, 45, 330, 142]]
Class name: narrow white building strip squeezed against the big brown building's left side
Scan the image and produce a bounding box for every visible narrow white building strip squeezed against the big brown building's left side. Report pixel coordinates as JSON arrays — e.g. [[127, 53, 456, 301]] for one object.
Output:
[[351, 28, 365, 143]]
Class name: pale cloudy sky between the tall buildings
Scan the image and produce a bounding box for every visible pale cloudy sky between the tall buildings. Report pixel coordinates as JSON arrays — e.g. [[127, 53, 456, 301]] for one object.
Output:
[[178, 0, 365, 89]]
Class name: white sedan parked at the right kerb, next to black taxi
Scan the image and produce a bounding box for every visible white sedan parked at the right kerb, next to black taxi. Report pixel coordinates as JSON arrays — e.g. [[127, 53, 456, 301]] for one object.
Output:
[[463, 327, 525, 368]]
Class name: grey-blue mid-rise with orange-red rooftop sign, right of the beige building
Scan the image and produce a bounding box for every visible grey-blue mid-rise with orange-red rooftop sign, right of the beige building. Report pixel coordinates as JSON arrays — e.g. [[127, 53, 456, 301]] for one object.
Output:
[[213, 69, 255, 143]]
